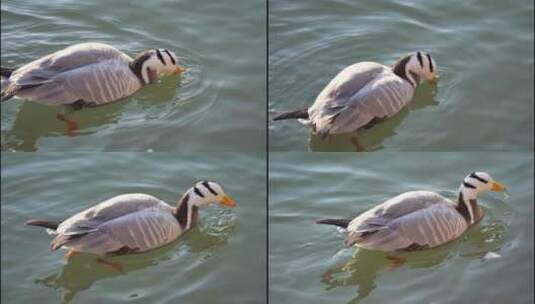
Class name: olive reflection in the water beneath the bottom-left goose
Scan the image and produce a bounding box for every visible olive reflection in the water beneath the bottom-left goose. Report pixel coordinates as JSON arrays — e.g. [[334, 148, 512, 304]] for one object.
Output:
[[35, 215, 235, 304]]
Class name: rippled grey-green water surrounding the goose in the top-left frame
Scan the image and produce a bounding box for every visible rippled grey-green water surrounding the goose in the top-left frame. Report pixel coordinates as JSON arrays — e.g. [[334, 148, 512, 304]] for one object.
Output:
[[1, 0, 266, 152]]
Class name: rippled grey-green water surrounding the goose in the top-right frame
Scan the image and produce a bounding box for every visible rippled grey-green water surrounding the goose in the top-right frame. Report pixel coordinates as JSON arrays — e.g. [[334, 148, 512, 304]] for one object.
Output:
[[268, 0, 534, 151]]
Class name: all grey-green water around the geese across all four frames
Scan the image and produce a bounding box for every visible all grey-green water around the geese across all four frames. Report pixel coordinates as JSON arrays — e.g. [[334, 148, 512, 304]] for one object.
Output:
[[0, 0, 534, 304]]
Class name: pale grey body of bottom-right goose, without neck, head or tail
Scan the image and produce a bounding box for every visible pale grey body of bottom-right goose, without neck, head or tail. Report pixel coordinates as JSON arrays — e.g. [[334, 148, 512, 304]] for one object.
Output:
[[346, 191, 467, 251]]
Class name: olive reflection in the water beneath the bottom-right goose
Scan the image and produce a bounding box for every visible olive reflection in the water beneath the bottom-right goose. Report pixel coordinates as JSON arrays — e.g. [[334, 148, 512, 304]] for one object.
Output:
[[321, 220, 507, 304]]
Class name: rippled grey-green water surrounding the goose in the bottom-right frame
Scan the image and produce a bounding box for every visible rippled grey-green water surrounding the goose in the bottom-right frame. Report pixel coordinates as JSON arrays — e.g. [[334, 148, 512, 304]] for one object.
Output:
[[269, 152, 534, 304]]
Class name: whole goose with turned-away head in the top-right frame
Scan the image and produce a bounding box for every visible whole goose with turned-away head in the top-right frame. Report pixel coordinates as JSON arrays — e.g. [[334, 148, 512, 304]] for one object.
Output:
[[273, 51, 438, 138]]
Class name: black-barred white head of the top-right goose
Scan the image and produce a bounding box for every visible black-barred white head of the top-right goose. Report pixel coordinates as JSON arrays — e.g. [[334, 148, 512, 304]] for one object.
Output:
[[392, 51, 437, 87]]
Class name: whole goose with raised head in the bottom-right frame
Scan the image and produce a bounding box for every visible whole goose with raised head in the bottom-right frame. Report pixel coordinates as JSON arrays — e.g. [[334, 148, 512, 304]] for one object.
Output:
[[316, 172, 505, 252]]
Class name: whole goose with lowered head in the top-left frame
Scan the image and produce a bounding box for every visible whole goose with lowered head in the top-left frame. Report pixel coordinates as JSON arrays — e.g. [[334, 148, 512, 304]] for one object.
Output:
[[2, 43, 181, 105]]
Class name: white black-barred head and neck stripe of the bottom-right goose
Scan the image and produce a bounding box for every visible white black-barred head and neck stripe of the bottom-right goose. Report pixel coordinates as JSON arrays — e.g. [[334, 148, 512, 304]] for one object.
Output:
[[459, 172, 505, 223]]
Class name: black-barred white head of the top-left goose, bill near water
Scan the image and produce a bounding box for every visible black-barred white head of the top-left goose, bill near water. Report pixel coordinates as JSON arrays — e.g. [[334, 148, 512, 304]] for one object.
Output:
[[130, 49, 184, 84]]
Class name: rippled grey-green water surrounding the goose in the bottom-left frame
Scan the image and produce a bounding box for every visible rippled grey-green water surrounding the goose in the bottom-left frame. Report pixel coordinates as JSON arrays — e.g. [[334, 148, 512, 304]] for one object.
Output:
[[1, 152, 266, 303]]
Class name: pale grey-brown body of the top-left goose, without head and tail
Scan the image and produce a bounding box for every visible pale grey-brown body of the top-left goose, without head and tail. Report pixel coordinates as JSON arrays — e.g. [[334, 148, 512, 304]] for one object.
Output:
[[6, 43, 141, 104]]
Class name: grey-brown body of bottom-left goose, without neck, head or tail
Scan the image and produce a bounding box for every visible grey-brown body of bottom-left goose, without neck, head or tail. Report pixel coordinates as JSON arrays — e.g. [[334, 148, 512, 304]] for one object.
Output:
[[51, 194, 184, 255]]
